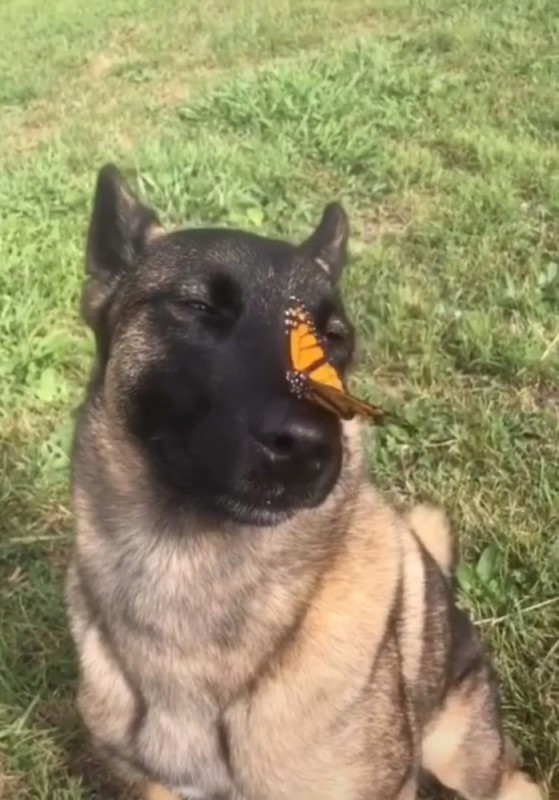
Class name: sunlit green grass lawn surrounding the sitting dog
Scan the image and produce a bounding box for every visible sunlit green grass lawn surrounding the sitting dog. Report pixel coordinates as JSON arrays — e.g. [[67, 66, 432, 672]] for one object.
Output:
[[0, 0, 559, 800]]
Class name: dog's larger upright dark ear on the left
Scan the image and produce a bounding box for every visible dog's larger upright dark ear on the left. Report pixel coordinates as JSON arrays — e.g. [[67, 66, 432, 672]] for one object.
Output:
[[81, 164, 163, 330]]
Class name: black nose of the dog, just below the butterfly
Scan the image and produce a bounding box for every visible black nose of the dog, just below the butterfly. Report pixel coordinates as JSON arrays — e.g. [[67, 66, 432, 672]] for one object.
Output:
[[258, 414, 334, 482]]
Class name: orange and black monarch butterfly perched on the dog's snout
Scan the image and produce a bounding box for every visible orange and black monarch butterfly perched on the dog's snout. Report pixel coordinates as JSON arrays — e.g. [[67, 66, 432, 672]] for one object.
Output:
[[285, 297, 398, 423]]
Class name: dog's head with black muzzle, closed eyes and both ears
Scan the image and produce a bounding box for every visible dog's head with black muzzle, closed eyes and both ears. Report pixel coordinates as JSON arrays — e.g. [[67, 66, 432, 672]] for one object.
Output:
[[82, 166, 353, 524]]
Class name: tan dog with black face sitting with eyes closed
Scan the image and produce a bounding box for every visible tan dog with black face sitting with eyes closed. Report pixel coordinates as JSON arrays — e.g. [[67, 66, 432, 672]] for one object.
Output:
[[67, 165, 542, 800]]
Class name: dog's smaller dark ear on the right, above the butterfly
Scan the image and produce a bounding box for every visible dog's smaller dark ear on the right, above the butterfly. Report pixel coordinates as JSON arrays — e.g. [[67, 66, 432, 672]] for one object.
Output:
[[301, 203, 349, 281]]
